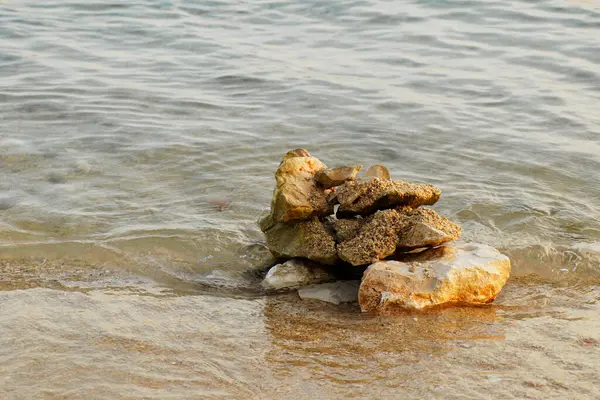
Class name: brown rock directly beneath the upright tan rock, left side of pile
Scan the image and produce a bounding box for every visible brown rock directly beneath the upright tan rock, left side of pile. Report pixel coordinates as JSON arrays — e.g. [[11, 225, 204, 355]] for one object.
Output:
[[265, 217, 338, 265]]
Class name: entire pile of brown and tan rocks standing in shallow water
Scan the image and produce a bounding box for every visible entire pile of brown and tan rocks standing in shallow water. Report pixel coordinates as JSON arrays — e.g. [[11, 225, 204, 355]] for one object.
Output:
[[259, 149, 510, 312]]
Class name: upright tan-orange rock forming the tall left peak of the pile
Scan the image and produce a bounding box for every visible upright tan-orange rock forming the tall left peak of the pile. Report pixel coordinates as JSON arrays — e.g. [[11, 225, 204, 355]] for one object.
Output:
[[268, 149, 333, 227]]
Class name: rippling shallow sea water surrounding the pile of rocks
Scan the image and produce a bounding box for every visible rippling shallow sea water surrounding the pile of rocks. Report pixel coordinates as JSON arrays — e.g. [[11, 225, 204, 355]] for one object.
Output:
[[0, 0, 600, 399]]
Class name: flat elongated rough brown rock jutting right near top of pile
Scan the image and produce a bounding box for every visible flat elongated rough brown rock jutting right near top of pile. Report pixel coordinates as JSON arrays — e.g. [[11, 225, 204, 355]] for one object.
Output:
[[336, 178, 441, 218]]
